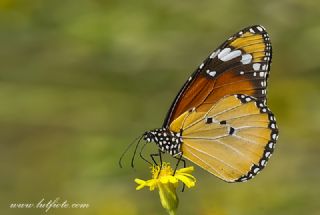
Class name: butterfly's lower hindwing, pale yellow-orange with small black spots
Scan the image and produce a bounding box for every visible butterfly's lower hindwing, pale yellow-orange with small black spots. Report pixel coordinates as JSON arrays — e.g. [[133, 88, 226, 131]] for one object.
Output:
[[170, 94, 278, 182]]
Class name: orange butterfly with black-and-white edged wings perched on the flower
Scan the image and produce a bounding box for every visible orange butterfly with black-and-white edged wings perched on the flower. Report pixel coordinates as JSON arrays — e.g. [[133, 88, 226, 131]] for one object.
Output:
[[121, 25, 278, 182]]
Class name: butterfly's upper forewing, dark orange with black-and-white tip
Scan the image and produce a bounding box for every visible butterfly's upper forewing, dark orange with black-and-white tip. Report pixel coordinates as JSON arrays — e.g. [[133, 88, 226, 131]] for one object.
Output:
[[163, 25, 271, 128]]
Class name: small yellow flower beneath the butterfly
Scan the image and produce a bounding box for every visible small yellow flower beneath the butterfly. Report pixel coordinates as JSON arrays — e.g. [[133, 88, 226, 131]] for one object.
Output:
[[135, 163, 196, 214]]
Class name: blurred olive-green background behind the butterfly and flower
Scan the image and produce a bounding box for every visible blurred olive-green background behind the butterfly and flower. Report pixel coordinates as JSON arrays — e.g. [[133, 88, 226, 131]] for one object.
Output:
[[0, 0, 320, 215]]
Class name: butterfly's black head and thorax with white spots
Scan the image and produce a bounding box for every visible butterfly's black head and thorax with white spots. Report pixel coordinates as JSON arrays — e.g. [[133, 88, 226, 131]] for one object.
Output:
[[143, 128, 183, 156]]
